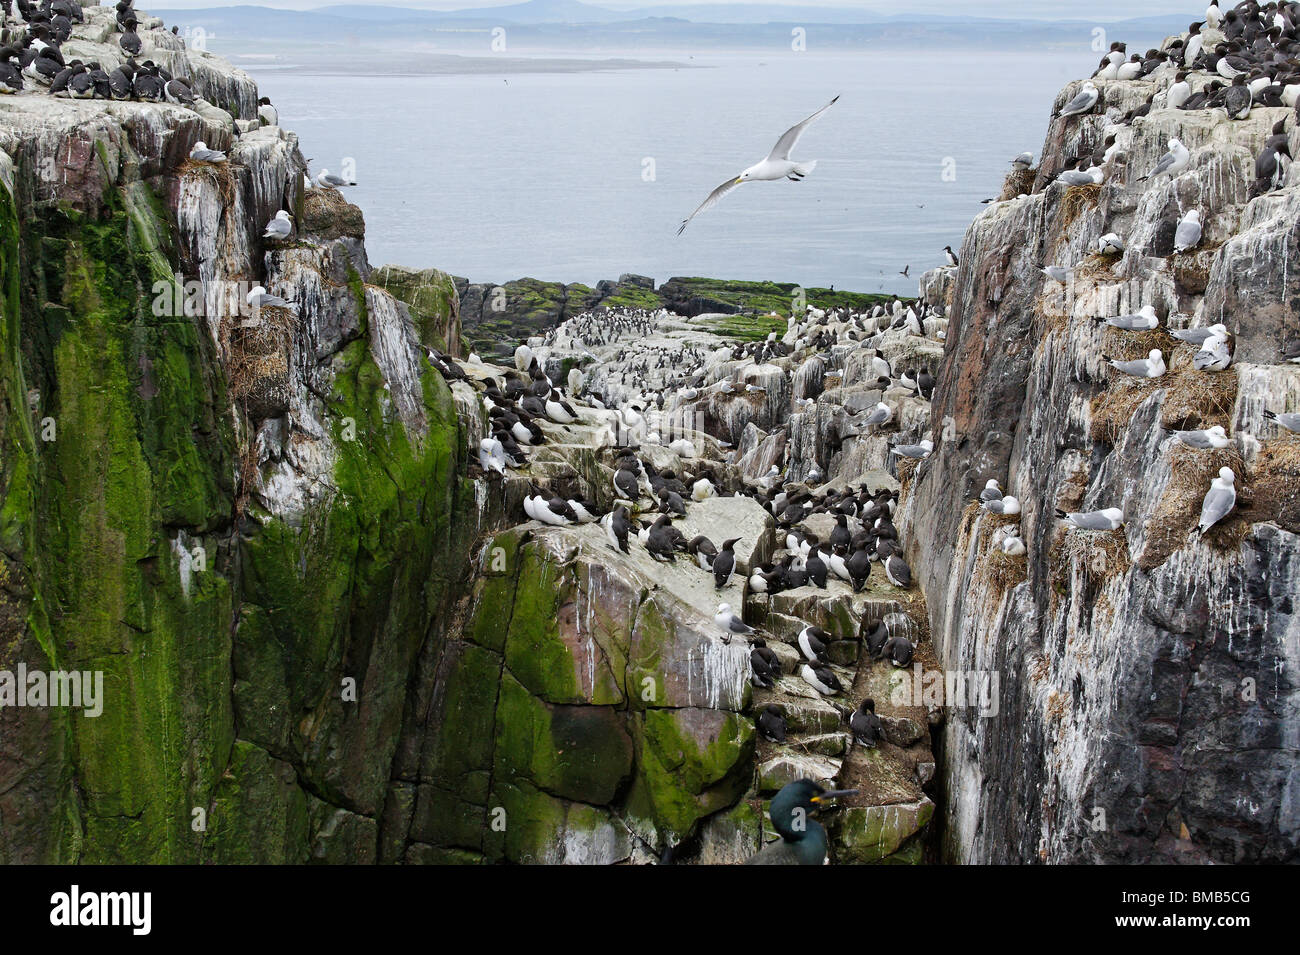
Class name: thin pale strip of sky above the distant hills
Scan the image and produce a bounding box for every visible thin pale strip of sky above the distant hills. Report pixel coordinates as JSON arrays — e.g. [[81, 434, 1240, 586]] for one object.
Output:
[[157, 0, 1203, 22]]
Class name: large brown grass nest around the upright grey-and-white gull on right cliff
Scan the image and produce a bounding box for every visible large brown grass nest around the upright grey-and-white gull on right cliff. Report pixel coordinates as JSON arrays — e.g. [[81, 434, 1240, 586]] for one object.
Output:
[[1138, 444, 1249, 570]]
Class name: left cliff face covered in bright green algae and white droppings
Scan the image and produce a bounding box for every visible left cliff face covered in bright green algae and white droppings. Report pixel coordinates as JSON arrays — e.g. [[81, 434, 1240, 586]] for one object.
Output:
[[0, 9, 473, 863]]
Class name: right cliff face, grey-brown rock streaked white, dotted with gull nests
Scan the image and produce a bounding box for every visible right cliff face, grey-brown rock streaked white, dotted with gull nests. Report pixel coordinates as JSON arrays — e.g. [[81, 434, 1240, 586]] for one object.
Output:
[[904, 46, 1300, 863]]
